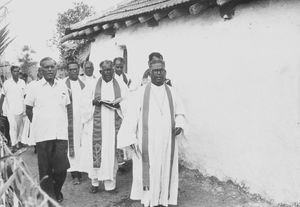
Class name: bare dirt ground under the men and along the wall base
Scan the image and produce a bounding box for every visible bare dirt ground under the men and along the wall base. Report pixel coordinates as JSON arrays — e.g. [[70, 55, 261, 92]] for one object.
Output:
[[22, 148, 276, 207]]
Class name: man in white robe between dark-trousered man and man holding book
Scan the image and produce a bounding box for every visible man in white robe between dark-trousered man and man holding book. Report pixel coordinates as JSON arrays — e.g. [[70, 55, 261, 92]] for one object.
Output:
[[65, 61, 85, 185]]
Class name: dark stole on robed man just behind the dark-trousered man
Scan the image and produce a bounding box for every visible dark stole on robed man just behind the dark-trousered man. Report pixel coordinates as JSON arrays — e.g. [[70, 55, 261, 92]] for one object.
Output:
[[66, 78, 85, 157]]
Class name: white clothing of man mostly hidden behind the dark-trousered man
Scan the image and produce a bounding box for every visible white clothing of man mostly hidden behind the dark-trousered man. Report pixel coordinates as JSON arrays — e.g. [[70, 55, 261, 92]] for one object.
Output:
[[22, 80, 38, 145]]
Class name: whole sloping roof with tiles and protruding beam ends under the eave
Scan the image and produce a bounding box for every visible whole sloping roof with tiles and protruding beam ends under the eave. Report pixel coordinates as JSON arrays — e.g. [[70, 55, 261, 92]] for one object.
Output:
[[61, 0, 241, 42]]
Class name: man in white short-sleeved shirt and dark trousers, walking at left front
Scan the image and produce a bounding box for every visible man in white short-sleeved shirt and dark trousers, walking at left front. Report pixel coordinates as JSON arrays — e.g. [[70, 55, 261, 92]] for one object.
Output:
[[25, 57, 70, 202]]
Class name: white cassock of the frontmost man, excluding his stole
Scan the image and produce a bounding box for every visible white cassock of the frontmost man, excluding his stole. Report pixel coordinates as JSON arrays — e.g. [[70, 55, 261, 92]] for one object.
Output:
[[118, 84, 185, 206]]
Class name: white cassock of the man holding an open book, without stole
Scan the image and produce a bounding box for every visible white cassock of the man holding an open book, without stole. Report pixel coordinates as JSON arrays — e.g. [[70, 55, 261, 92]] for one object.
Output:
[[81, 80, 128, 190]]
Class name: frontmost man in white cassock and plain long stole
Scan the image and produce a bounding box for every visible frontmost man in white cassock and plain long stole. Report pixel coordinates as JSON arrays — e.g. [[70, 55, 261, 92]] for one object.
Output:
[[118, 60, 185, 207]]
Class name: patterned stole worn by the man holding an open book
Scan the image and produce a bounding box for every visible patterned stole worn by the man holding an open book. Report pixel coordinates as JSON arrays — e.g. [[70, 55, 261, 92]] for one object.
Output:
[[93, 78, 123, 168]]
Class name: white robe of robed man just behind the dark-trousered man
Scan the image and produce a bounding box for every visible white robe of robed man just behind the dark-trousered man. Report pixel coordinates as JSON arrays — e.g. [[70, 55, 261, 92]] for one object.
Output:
[[68, 80, 84, 172]]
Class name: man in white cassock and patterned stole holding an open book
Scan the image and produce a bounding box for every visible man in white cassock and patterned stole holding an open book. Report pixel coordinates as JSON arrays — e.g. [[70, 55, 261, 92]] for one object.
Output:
[[81, 60, 128, 193]]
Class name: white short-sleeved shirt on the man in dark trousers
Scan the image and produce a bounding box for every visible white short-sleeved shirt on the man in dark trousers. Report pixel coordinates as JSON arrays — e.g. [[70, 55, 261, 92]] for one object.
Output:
[[25, 79, 70, 142]]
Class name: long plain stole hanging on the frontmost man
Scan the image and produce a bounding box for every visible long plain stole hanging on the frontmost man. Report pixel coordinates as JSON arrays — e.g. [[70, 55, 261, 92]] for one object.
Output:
[[142, 83, 175, 196]]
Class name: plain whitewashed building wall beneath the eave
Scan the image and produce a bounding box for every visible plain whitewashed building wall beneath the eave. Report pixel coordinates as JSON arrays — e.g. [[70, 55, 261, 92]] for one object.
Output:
[[90, 0, 300, 203]]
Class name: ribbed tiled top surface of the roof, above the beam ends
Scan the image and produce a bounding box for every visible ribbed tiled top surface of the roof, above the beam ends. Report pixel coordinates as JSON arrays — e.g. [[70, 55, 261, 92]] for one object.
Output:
[[70, 0, 204, 30]]
